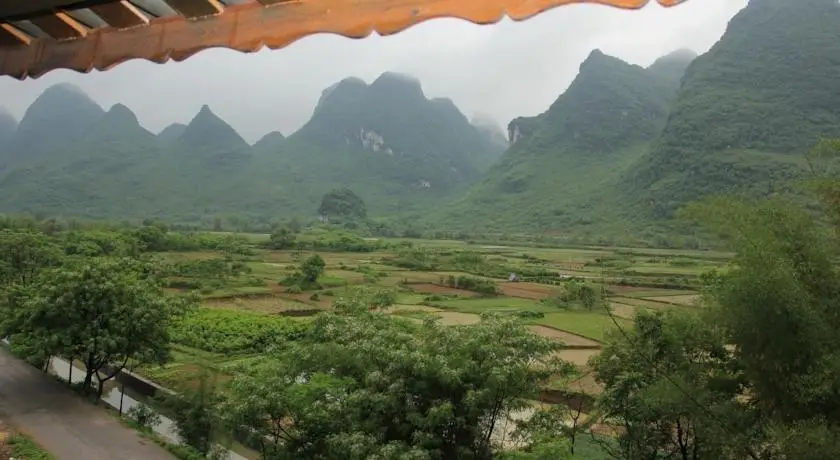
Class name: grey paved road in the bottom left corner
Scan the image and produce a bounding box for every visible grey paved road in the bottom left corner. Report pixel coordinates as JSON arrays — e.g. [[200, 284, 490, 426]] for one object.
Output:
[[0, 346, 173, 460]]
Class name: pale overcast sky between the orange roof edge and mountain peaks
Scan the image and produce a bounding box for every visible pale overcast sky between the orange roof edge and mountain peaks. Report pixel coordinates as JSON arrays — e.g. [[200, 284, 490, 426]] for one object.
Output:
[[0, 0, 747, 142]]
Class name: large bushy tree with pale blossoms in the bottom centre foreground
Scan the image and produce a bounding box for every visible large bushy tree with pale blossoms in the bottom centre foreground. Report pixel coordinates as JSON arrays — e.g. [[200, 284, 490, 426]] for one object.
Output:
[[223, 311, 569, 460]]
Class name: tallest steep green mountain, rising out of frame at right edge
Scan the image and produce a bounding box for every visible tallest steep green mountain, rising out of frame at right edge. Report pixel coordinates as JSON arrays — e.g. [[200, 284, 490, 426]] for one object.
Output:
[[618, 0, 840, 218]]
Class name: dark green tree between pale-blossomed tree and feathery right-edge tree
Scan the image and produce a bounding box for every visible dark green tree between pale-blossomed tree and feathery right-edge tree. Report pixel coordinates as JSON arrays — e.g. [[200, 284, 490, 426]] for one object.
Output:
[[593, 311, 754, 460]]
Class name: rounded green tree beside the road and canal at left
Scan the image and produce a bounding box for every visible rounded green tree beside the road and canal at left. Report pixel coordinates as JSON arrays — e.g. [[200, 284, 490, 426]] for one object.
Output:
[[0, 258, 194, 395]]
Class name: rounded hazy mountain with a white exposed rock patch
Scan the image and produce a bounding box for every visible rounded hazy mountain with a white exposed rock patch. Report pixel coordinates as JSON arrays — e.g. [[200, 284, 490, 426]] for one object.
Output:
[[244, 73, 503, 215]]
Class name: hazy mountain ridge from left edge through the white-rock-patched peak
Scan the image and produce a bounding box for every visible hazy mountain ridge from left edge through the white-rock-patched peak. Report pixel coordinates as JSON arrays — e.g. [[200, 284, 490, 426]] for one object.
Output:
[[0, 73, 503, 220]]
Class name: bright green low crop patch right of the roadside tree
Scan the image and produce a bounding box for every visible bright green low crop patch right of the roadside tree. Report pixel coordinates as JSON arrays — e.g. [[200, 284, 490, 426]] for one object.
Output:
[[170, 309, 307, 355]]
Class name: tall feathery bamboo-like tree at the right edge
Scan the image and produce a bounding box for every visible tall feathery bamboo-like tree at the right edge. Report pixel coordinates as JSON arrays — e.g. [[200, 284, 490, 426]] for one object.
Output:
[[692, 199, 840, 423]]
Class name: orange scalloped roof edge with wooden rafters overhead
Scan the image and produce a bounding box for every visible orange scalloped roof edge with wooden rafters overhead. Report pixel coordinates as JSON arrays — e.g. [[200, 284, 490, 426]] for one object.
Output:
[[0, 0, 684, 79]]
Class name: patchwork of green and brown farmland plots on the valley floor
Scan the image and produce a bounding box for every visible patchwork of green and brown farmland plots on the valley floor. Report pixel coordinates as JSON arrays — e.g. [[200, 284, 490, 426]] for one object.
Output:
[[139, 230, 728, 402]]
